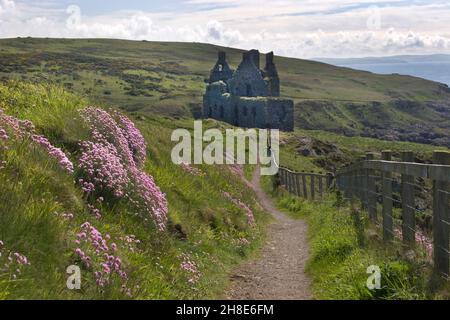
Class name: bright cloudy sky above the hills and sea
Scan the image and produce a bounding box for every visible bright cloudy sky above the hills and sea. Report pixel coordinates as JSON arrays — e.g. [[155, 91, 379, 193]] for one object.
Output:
[[0, 0, 450, 58]]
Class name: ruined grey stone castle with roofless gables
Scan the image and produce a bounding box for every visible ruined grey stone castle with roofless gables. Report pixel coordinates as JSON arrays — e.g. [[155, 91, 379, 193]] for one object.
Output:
[[203, 50, 294, 131]]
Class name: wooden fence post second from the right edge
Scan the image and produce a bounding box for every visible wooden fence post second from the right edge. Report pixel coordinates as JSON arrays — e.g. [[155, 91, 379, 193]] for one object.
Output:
[[401, 151, 416, 245]]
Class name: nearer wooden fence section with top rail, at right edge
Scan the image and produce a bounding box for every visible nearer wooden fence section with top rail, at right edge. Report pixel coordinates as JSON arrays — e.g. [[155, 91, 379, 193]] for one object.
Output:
[[336, 151, 450, 278]]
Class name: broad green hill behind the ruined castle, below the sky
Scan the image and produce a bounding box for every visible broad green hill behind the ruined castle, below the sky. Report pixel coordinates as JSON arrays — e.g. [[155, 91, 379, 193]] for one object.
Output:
[[0, 38, 450, 146]]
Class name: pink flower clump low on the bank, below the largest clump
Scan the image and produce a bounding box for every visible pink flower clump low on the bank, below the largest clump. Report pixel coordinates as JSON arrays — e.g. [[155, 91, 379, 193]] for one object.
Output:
[[75, 222, 131, 294]]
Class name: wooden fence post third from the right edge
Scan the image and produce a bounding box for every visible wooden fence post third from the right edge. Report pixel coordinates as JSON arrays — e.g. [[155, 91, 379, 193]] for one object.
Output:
[[381, 150, 394, 240]]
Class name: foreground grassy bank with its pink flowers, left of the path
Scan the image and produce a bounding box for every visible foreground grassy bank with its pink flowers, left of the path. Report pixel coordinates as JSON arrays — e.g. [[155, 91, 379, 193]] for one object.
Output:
[[0, 82, 268, 299]]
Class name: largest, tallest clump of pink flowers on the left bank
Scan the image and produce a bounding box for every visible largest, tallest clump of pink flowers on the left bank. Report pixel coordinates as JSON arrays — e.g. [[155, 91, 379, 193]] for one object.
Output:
[[79, 107, 168, 230]]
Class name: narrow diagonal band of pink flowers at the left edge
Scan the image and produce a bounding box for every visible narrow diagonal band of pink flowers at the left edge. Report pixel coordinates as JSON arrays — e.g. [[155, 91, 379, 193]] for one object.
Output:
[[0, 109, 73, 173]]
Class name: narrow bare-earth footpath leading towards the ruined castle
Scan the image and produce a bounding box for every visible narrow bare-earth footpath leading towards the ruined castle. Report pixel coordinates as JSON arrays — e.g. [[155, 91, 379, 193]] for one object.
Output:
[[225, 168, 311, 300]]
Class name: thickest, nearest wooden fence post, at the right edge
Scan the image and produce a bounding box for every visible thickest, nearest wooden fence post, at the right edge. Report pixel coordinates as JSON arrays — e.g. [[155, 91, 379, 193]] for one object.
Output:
[[433, 151, 450, 277]]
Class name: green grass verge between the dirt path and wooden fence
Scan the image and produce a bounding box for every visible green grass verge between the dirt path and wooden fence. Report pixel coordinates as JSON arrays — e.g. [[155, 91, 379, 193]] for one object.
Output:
[[264, 179, 450, 300]]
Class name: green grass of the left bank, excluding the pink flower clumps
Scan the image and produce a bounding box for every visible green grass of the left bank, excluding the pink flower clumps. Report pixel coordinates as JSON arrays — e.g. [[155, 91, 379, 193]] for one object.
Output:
[[0, 84, 268, 299]]
